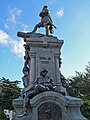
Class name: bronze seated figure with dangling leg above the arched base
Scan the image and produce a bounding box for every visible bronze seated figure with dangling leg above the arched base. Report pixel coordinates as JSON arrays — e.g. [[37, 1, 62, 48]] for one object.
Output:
[[18, 68, 56, 118]]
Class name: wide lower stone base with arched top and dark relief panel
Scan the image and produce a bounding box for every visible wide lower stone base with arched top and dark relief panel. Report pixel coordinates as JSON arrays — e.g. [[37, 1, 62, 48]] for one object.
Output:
[[13, 91, 86, 120]]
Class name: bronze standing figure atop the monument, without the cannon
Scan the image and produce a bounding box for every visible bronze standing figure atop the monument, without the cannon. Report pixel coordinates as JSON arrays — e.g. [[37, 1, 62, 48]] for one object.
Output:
[[32, 5, 56, 35]]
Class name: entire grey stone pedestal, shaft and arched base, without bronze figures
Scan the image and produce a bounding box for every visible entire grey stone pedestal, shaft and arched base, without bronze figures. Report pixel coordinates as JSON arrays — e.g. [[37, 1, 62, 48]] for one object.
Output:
[[13, 33, 86, 120]]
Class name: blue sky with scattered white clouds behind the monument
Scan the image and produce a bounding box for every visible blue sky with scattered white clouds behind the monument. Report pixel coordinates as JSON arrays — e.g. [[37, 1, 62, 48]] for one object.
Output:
[[0, 0, 90, 85]]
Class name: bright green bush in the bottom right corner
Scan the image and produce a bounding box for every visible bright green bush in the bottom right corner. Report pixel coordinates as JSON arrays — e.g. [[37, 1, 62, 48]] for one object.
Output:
[[81, 100, 90, 120]]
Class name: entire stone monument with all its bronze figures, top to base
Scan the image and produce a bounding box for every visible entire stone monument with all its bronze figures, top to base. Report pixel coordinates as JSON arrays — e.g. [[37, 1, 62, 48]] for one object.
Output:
[[13, 6, 86, 120]]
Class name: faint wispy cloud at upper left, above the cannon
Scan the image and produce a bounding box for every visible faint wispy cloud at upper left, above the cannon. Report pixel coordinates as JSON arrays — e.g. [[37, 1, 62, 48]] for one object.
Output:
[[4, 5, 29, 31]]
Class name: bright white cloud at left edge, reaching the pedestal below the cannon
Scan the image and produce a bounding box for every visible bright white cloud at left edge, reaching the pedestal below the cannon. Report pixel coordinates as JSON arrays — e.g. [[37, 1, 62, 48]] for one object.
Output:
[[0, 30, 25, 57]]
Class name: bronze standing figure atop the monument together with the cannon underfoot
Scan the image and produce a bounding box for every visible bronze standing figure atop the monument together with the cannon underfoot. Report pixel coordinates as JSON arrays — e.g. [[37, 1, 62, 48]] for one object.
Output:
[[17, 5, 56, 40]]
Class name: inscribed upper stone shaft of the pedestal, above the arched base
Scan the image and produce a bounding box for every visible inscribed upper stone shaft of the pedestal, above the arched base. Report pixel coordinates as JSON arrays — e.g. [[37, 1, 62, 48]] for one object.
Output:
[[24, 33, 65, 91]]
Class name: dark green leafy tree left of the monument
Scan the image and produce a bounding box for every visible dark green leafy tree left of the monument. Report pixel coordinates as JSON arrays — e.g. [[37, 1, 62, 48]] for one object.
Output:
[[0, 77, 21, 109]]
